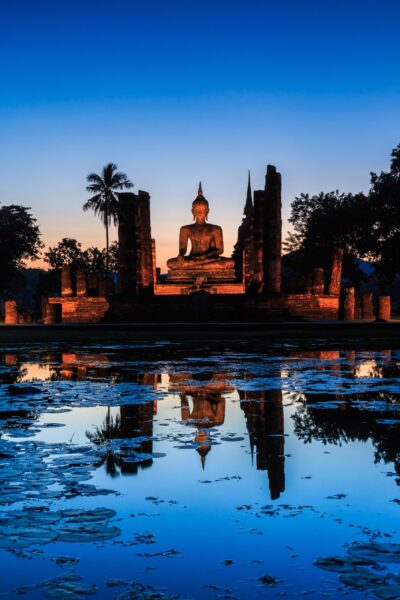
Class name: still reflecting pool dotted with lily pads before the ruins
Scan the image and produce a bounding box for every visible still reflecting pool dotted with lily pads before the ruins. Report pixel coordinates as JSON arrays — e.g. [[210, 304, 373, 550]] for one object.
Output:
[[0, 341, 400, 599]]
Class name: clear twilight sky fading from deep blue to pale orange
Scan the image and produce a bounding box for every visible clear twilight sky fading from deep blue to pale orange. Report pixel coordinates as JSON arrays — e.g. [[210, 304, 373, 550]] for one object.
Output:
[[0, 0, 400, 267]]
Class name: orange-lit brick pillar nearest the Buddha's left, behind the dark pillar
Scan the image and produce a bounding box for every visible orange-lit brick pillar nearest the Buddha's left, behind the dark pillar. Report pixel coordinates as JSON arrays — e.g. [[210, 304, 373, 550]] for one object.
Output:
[[136, 190, 154, 292]]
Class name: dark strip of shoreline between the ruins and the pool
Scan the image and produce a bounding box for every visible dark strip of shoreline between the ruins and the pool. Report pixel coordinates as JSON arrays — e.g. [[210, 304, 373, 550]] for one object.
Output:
[[0, 320, 400, 346]]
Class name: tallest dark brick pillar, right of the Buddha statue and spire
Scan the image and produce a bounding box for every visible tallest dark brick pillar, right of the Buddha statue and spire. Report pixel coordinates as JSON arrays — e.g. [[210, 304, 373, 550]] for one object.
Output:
[[263, 165, 282, 294]]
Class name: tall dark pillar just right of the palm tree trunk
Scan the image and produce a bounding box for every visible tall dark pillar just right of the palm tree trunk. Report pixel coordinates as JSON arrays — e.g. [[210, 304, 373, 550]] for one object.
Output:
[[117, 192, 138, 296]]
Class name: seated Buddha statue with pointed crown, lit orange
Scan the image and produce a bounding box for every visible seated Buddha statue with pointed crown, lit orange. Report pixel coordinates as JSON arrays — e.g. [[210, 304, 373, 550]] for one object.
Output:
[[167, 183, 235, 271]]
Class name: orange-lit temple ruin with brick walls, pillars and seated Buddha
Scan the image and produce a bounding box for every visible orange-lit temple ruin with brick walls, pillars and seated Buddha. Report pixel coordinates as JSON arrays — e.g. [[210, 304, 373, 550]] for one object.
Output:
[[44, 165, 348, 323]]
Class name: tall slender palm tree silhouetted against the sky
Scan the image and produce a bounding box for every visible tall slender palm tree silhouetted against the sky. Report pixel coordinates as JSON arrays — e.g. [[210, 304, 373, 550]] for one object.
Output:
[[83, 163, 133, 271]]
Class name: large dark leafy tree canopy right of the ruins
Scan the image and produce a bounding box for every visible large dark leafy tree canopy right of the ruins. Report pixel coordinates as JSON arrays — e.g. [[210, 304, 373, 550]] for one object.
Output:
[[284, 145, 400, 279]]
